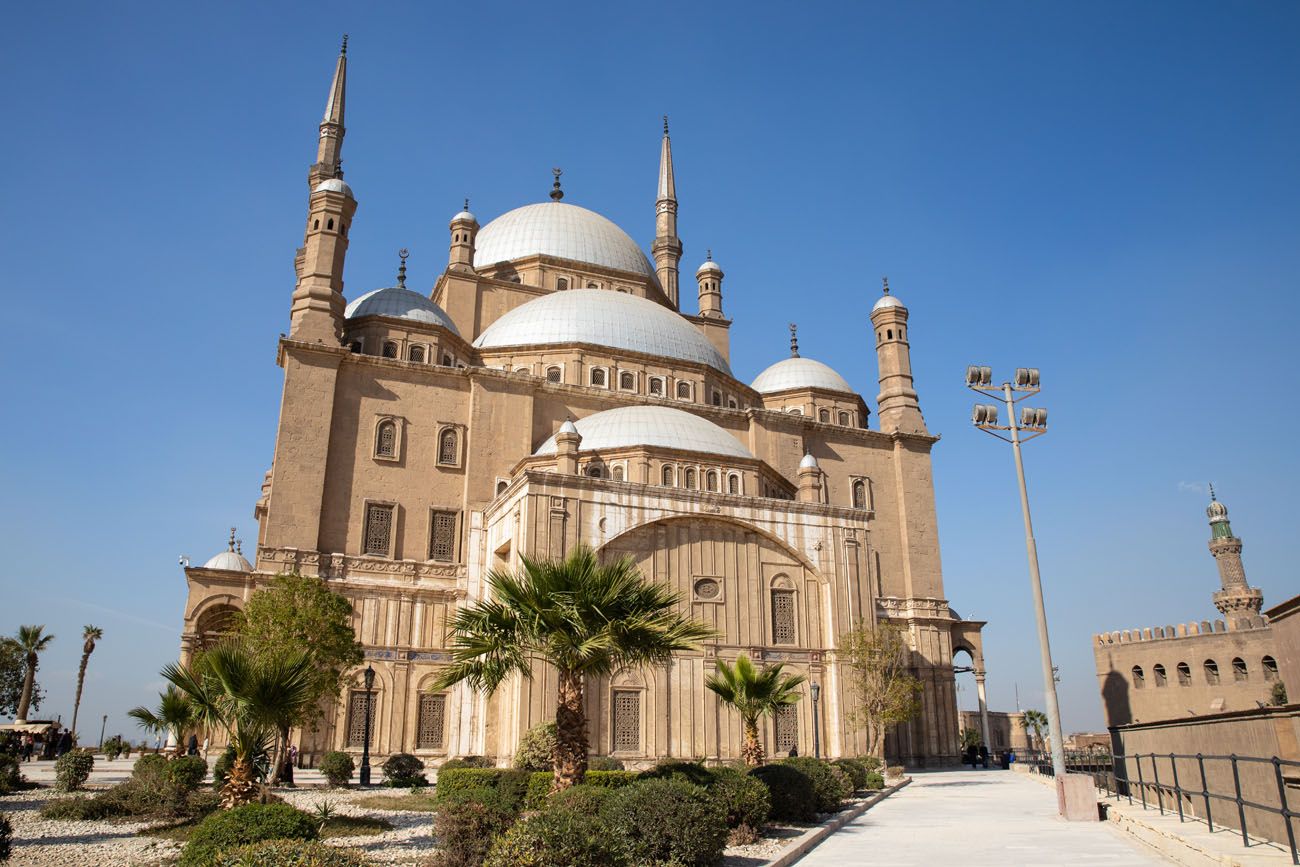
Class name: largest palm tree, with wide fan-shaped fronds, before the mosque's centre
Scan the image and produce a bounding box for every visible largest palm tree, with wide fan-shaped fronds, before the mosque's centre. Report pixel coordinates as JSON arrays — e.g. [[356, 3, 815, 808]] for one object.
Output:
[[434, 546, 716, 792]]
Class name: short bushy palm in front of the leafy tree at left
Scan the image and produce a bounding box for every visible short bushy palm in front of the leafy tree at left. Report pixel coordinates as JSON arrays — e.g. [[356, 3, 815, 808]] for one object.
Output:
[[163, 638, 316, 809]]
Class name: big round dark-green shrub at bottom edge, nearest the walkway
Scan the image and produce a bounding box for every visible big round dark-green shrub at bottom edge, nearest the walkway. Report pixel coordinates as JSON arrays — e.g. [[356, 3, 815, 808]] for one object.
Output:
[[601, 779, 727, 867]]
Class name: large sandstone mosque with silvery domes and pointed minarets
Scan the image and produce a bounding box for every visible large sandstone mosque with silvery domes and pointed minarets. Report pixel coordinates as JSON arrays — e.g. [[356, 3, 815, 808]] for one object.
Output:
[[182, 42, 984, 767]]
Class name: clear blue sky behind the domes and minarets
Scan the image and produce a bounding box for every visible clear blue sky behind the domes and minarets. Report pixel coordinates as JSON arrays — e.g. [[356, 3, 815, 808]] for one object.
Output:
[[0, 3, 1300, 748]]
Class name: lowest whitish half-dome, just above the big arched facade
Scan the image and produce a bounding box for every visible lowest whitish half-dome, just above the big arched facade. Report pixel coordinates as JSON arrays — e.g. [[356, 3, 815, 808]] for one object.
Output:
[[533, 407, 754, 458]]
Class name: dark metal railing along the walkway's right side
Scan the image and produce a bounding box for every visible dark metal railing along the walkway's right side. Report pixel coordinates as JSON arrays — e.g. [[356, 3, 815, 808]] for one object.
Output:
[[1022, 753, 1300, 864]]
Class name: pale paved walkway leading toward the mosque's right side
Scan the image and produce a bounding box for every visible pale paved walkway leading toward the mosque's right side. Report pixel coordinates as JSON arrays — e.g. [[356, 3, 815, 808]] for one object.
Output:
[[798, 771, 1170, 867]]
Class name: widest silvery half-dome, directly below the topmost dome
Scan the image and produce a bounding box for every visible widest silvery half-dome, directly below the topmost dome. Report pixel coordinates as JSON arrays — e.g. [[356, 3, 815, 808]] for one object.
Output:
[[475, 289, 731, 376]]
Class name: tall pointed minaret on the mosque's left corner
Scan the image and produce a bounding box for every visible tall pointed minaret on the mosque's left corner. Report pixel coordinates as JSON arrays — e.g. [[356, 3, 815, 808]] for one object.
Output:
[[289, 36, 356, 343]]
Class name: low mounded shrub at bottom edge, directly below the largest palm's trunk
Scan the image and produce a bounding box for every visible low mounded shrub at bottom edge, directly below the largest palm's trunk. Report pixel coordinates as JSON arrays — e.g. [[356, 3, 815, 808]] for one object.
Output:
[[484, 805, 632, 867]]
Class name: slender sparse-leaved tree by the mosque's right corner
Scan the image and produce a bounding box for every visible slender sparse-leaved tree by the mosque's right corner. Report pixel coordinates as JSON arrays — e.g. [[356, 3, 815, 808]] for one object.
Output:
[[839, 621, 920, 763]]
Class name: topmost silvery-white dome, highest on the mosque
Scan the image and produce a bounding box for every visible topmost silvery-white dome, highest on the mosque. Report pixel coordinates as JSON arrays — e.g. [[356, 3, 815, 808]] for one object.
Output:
[[475, 201, 655, 278]]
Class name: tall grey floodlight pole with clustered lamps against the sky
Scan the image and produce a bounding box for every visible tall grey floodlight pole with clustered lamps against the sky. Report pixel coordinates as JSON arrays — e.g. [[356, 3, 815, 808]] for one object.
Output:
[[966, 365, 1066, 785]]
